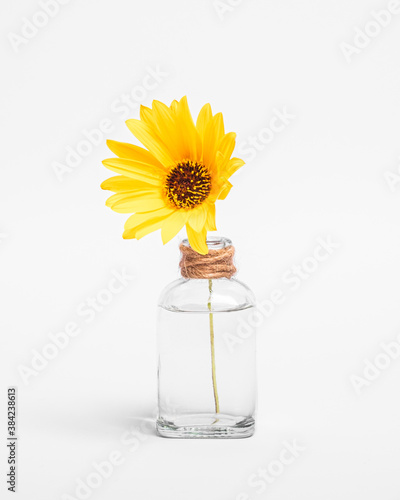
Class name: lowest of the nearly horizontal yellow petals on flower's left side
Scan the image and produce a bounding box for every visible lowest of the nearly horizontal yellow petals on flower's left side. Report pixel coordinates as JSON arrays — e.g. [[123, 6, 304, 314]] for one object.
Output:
[[106, 190, 165, 214]]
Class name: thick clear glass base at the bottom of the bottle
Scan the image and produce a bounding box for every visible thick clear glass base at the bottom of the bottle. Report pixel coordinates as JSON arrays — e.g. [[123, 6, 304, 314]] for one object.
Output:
[[156, 414, 255, 439]]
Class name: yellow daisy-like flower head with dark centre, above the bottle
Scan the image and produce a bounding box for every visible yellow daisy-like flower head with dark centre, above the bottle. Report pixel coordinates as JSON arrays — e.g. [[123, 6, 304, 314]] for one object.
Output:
[[101, 97, 244, 255]]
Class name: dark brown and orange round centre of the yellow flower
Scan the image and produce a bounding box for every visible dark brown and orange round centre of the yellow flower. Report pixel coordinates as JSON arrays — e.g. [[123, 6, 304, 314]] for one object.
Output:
[[165, 160, 211, 208]]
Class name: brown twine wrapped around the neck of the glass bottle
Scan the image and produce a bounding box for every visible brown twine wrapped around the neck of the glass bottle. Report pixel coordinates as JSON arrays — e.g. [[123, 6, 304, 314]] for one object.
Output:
[[179, 243, 236, 279]]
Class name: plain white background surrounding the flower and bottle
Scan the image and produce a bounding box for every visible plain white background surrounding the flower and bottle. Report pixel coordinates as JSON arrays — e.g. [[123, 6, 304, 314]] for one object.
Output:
[[0, 0, 400, 500]]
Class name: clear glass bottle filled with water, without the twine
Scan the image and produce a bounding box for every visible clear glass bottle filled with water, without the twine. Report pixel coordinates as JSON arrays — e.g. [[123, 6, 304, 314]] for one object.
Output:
[[156, 237, 256, 438]]
